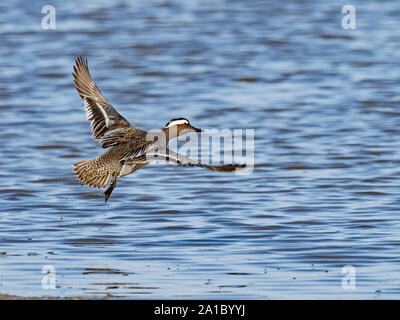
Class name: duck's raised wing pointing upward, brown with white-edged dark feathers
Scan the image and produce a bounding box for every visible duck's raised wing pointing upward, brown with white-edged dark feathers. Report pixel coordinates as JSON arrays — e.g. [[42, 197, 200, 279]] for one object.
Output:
[[72, 57, 137, 148]]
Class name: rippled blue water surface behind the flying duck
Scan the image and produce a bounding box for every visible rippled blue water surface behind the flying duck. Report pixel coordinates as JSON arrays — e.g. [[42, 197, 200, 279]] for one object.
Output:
[[0, 0, 400, 299]]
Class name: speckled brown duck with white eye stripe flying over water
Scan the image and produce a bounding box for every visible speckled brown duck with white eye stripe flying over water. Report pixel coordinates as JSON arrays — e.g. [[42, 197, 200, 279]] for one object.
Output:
[[72, 57, 245, 202]]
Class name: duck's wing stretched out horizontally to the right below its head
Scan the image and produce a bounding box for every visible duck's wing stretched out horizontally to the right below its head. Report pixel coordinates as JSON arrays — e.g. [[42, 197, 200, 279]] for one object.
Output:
[[145, 148, 246, 172]]
